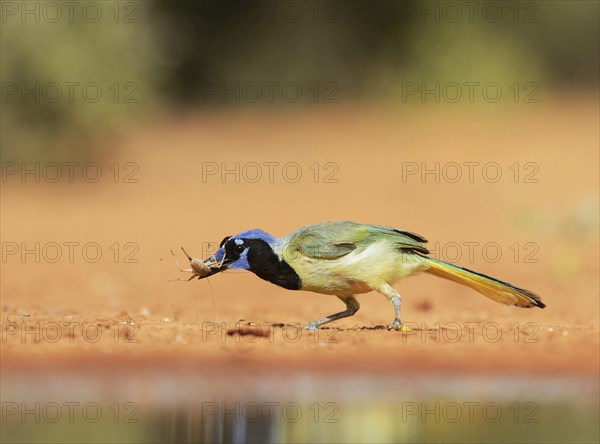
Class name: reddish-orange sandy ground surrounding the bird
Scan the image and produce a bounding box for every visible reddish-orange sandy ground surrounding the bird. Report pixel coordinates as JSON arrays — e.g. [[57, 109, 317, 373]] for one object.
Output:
[[1, 100, 600, 384]]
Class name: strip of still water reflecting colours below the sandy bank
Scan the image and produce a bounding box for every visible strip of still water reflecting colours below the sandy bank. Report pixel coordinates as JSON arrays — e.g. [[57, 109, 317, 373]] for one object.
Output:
[[1, 375, 600, 443]]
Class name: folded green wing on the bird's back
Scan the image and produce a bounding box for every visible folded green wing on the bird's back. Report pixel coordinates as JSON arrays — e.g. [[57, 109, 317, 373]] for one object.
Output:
[[286, 221, 429, 259]]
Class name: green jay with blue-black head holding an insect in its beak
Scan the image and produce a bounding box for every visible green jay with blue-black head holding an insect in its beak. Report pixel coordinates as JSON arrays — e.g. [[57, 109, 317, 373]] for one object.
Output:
[[185, 221, 545, 330]]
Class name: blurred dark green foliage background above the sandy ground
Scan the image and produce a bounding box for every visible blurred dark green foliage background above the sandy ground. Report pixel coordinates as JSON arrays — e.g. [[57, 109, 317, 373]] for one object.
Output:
[[0, 1, 600, 161]]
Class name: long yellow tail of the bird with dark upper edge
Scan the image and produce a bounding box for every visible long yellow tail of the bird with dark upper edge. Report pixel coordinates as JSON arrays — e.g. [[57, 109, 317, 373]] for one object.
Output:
[[423, 256, 546, 308]]
